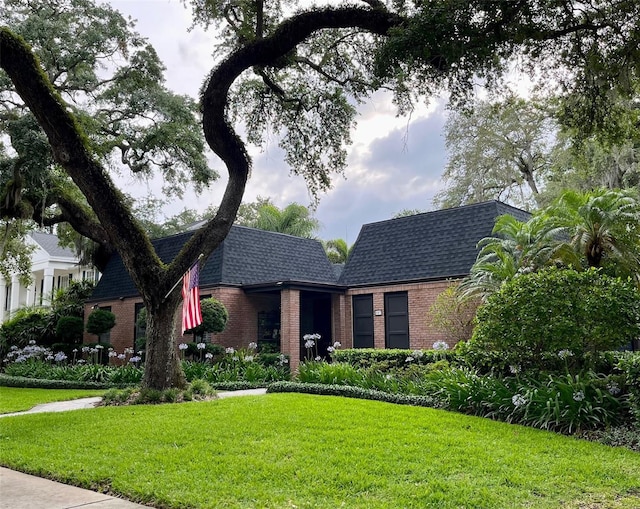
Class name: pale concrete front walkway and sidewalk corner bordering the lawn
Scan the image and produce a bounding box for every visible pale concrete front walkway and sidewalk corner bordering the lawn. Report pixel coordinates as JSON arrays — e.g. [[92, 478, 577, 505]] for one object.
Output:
[[0, 389, 267, 509]]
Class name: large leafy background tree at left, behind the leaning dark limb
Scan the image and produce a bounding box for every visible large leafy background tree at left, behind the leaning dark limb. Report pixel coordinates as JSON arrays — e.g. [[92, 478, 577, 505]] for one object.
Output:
[[0, 0, 218, 278]]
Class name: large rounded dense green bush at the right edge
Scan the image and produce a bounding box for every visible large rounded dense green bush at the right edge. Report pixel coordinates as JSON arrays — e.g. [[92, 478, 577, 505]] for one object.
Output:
[[467, 268, 640, 371]]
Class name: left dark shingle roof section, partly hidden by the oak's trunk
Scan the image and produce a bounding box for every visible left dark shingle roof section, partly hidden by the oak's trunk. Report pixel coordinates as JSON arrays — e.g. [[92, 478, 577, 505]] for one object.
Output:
[[92, 226, 337, 300]]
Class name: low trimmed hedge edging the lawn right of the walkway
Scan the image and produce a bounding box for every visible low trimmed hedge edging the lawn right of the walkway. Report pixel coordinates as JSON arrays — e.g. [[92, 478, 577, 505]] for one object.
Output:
[[267, 382, 441, 408]]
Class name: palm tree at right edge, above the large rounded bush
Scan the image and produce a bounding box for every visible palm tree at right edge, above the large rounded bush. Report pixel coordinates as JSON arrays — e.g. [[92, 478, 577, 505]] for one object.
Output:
[[544, 189, 640, 280]]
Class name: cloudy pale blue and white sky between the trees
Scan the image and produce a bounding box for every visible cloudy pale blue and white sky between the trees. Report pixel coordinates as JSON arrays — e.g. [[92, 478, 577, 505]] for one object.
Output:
[[107, 0, 447, 244]]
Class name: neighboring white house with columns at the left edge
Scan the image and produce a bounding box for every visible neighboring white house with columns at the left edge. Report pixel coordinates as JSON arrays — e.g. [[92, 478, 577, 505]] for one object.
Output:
[[0, 232, 99, 323]]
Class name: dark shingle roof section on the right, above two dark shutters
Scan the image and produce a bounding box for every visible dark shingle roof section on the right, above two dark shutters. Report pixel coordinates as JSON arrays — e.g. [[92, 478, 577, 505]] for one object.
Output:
[[339, 201, 530, 286]]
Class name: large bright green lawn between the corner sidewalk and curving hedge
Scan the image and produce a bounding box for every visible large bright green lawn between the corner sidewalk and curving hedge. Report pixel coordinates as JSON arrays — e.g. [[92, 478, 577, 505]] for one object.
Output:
[[0, 394, 640, 509]]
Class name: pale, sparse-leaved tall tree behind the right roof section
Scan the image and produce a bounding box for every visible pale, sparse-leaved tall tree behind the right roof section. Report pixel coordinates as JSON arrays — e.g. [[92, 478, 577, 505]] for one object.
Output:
[[434, 96, 556, 209]]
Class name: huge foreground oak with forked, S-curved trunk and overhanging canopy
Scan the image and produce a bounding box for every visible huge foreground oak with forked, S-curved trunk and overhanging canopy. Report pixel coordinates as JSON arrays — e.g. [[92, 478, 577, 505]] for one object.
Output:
[[0, 0, 640, 389]]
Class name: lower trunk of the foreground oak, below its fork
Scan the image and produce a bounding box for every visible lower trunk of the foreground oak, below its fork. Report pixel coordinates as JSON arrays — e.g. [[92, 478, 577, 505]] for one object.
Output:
[[142, 292, 187, 390]]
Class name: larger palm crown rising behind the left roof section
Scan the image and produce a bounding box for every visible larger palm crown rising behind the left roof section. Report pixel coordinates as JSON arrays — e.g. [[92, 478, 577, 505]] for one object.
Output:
[[250, 203, 320, 239]]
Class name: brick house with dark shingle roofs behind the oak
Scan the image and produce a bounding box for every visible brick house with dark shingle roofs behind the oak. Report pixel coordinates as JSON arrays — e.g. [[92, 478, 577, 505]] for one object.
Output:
[[85, 201, 530, 368]]
